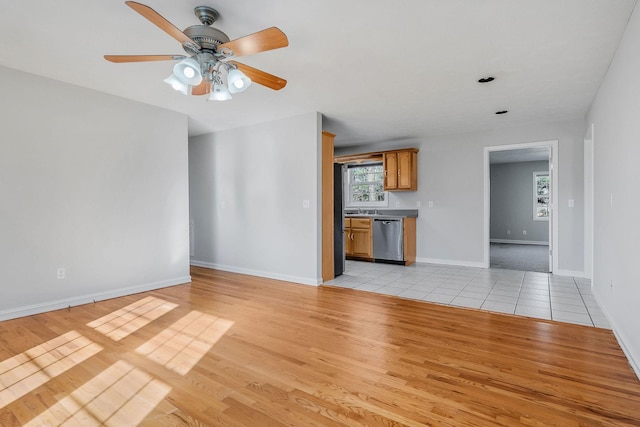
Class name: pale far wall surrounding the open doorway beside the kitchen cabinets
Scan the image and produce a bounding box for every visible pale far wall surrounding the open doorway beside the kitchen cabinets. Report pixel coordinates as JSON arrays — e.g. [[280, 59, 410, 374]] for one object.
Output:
[[336, 120, 585, 274]]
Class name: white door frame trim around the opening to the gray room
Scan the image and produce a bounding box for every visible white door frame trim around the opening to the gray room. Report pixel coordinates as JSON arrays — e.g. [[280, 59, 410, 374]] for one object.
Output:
[[484, 139, 559, 273]]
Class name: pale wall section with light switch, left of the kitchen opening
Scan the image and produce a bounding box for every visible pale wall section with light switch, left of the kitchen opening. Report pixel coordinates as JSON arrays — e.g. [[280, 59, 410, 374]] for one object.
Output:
[[189, 113, 322, 285]]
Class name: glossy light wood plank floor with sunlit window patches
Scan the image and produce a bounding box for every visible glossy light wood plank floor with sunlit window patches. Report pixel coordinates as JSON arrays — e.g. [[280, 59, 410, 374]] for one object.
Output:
[[0, 268, 640, 427]]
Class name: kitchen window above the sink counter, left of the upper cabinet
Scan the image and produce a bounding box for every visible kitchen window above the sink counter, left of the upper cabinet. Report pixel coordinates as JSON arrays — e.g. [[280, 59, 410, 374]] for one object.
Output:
[[345, 163, 389, 207]]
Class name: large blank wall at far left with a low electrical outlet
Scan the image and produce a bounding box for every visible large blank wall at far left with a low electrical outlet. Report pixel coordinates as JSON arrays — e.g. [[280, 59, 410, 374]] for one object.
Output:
[[0, 67, 189, 320]]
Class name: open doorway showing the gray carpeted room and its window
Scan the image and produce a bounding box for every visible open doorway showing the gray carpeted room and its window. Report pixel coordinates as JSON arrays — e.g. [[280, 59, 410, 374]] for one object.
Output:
[[484, 141, 558, 272]]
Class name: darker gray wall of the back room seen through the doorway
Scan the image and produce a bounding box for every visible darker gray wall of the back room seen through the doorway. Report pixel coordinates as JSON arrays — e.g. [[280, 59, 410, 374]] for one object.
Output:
[[490, 161, 549, 243]]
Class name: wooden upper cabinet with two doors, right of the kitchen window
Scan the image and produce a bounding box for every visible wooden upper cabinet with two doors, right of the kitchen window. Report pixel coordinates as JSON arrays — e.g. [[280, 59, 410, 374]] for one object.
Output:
[[383, 149, 418, 191]]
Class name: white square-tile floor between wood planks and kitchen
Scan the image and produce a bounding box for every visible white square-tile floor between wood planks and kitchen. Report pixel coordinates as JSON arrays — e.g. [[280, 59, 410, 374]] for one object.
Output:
[[326, 261, 611, 329]]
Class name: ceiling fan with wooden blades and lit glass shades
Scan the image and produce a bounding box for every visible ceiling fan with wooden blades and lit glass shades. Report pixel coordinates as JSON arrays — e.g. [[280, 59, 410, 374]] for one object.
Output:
[[104, 1, 289, 101]]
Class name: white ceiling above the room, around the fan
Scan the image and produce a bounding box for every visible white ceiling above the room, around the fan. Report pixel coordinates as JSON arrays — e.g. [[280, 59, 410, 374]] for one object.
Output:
[[0, 0, 635, 146]]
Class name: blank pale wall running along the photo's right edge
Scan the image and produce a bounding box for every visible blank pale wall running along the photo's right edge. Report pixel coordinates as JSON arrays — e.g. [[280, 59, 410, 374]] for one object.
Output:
[[585, 8, 640, 376]]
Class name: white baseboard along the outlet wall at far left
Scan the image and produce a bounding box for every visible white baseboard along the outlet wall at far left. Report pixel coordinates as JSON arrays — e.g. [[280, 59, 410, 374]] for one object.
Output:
[[0, 276, 191, 321]]
